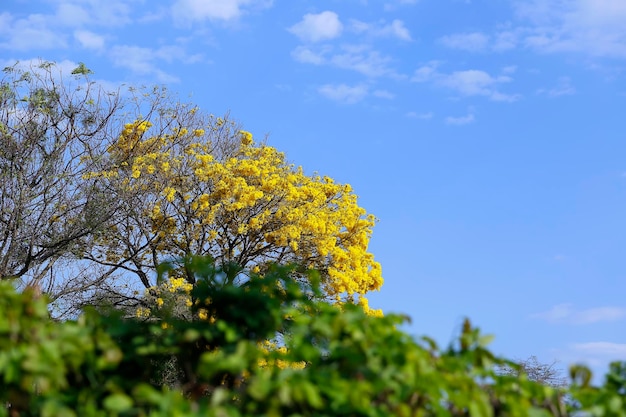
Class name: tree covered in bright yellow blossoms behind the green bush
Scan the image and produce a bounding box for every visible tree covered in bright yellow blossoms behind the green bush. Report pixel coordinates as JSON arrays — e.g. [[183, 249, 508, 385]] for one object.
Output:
[[86, 108, 383, 309]]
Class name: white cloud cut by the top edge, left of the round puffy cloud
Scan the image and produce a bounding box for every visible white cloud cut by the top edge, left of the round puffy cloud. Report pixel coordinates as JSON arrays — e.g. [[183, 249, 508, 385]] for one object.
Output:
[[171, 0, 272, 23]]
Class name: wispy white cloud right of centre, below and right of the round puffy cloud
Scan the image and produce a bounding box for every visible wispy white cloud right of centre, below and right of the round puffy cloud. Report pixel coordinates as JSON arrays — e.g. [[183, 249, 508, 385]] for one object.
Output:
[[411, 62, 520, 102]]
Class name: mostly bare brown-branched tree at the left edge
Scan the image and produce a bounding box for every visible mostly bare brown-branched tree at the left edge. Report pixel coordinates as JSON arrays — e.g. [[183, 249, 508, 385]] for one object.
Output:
[[0, 62, 122, 306]]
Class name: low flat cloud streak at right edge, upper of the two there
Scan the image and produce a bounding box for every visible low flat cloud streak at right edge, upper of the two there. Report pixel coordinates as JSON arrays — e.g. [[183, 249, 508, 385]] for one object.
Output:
[[531, 304, 626, 325]]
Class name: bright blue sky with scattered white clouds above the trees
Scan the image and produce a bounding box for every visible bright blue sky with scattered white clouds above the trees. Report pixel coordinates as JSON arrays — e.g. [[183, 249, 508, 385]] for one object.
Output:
[[0, 0, 626, 380]]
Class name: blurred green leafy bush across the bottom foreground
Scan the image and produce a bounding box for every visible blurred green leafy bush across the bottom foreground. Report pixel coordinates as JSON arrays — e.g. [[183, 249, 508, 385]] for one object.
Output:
[[0, 259, 626, 417]]
